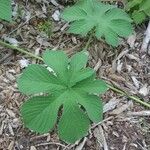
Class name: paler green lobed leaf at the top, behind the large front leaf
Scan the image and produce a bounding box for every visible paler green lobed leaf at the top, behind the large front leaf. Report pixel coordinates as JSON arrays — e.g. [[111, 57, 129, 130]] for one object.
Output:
[[62, 0, 132, 46]]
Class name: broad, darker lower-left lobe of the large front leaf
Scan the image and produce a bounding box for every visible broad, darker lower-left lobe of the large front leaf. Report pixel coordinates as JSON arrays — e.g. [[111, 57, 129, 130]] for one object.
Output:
[[21, 96, 61, 133]]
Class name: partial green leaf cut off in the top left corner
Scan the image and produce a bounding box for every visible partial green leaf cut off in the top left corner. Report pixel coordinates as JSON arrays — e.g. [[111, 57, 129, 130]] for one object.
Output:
[[0, 0, 12, 21]]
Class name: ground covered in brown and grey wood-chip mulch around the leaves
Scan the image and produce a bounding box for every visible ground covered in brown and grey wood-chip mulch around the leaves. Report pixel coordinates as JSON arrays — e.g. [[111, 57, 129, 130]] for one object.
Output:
[[0, 0, 150, 150]]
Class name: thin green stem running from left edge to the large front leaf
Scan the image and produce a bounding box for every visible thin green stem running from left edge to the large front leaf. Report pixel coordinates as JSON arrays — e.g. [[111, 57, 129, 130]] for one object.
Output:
[[0, 40, 43, 61]]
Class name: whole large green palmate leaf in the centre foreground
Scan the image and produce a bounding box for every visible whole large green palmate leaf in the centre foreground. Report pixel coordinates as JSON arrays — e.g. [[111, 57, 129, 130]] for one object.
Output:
[[18, 50, 108, 143]]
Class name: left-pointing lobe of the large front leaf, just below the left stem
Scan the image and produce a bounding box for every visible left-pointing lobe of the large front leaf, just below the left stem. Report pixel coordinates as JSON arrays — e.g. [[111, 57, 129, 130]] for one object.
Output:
[[18, 65, 65, 94]]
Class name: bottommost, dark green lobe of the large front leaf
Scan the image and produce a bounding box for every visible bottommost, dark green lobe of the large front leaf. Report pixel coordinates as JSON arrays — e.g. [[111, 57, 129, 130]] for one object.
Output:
[[58, 101, 90, 143]]
